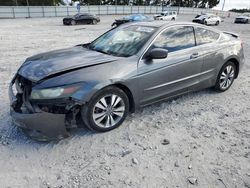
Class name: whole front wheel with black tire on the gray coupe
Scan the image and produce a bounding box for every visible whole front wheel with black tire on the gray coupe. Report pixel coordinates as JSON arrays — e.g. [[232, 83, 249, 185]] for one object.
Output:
[[81, 86, 129, 132]]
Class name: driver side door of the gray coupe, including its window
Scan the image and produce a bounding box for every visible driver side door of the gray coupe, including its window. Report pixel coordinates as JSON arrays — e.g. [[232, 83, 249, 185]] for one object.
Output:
[[138, 26, 203, 106]]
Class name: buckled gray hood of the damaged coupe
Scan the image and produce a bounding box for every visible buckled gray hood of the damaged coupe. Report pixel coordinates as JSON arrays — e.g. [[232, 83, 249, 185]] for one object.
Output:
[[18, 46, 120, 82]]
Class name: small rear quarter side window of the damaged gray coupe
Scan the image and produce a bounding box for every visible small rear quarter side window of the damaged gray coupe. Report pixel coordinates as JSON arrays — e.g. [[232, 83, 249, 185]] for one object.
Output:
[[195, 27, 220, 45]]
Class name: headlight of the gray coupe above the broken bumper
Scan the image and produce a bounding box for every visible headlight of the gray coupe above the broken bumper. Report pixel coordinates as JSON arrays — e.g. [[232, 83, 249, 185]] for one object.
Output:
[[30, 85, 80, 99]]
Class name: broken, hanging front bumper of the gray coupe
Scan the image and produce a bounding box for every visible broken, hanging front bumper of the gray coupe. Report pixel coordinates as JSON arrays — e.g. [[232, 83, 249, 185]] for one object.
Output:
[[9, 82, 70, 141]]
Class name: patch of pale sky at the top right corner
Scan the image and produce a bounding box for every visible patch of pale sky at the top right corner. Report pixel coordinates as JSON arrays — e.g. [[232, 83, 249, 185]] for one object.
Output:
[[216, 0, 250, 10]]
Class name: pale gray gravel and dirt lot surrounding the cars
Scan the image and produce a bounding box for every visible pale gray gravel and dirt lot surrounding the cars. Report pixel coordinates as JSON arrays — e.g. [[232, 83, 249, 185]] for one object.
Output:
[[0, 15, 250, 188]]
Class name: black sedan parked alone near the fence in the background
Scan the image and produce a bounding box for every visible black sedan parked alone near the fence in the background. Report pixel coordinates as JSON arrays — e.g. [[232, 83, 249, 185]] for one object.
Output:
[[63, 13, 100, 25]]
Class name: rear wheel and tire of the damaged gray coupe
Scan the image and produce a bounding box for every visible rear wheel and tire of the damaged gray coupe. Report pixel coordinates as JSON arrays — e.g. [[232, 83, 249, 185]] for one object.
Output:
[[214, 61, 237, 92]]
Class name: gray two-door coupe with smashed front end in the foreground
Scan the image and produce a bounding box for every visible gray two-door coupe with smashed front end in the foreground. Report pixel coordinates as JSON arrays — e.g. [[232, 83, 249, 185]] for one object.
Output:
[[9, 21, 244, 140]]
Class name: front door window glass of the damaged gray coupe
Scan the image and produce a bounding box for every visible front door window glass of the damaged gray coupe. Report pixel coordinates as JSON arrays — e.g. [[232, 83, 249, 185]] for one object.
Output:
[[151, 26, 195, 52]]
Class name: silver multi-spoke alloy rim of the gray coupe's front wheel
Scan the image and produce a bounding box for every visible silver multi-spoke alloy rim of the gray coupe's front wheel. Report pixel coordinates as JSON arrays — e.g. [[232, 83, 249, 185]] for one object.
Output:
[[92, 94, 125, 128]]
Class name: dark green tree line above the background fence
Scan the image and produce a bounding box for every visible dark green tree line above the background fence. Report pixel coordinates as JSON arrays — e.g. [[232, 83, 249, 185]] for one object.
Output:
[[0, 0, 220, 8]]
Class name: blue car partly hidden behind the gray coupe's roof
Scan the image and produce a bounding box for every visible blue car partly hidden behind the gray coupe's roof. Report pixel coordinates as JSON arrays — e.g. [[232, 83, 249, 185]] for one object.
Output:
[[111, 14, 153, 27]]
